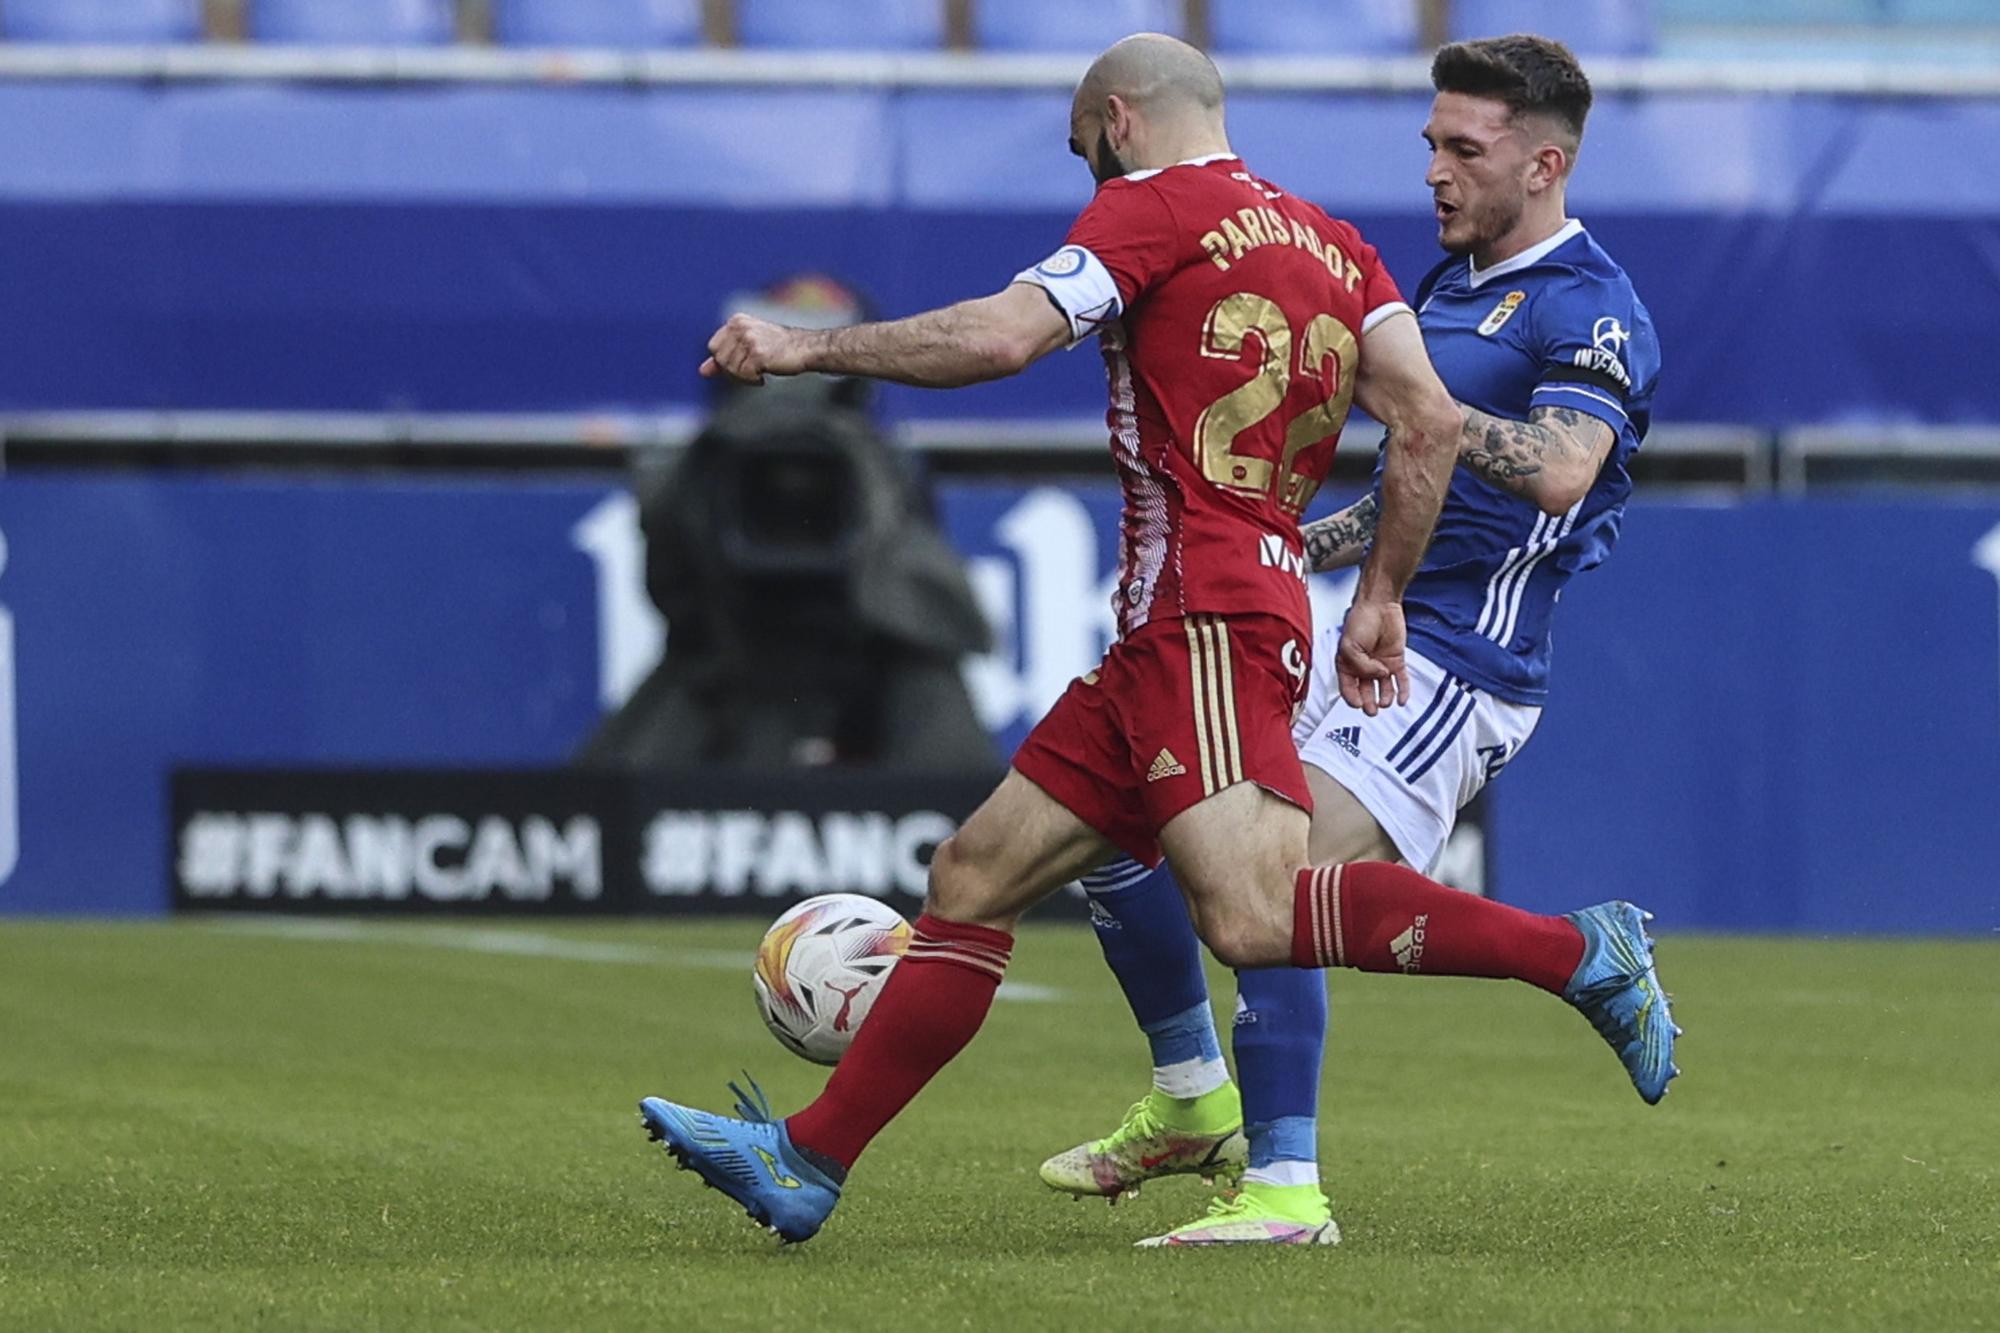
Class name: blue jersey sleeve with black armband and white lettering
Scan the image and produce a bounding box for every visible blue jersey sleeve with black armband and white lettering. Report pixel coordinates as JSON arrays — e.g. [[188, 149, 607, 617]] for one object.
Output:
[[1528, 274, 1652, 434]]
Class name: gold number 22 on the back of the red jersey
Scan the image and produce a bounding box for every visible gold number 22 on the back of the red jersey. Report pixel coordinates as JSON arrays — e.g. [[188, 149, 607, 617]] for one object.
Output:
[[1194, 292, 1360, 514]]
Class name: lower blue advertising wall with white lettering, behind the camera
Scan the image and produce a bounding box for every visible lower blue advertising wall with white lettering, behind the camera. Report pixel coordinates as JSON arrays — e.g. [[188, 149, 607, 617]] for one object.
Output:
[[0, 474, 2000, 933]]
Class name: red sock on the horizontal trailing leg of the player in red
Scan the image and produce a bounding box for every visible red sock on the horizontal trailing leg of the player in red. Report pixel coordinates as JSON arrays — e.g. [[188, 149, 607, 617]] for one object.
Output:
[[1292, 861, 1584, 995]]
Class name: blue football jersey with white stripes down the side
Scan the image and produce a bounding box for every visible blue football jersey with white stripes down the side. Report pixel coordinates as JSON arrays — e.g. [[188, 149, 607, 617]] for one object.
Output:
[[1376, 220, 1660, 705]]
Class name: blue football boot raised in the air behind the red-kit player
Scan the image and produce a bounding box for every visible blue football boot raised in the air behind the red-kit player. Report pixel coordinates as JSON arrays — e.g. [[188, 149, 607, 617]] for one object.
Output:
[[1562, 903, 1680, 1105]]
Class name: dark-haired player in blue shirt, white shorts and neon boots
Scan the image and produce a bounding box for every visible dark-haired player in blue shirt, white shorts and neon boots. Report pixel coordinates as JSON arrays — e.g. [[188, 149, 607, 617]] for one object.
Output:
[[1042, 36, 1678, 1245]]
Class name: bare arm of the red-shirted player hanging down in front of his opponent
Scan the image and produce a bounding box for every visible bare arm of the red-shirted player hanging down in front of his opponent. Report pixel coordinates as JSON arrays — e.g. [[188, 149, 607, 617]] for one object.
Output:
[[1336, 310, 1464, 717]]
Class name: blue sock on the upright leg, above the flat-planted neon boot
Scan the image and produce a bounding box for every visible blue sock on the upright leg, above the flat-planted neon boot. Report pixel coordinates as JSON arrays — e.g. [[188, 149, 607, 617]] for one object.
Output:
[[1230, 967, 1326, 1185]]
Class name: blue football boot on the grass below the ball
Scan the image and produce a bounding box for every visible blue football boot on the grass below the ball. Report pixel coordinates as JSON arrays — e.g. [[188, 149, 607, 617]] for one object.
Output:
[[638, 1075, 840, 1243]]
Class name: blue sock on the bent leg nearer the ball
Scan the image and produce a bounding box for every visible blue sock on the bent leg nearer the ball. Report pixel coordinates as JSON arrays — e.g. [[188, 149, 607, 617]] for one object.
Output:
[[1084, 861, 1230, 1097]]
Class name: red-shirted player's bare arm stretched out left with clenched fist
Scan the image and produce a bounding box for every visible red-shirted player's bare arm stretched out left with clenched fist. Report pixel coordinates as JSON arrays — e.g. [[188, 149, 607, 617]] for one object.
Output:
[[702, 282, 1070, 388]]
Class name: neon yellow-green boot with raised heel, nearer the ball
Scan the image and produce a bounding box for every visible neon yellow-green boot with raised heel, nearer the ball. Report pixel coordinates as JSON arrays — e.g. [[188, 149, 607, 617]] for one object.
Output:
[[1042, 1083, 1250, 1203]]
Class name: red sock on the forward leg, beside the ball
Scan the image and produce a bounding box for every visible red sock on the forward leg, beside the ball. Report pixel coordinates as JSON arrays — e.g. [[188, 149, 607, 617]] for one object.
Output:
[[784, 913, 1014, 1167]]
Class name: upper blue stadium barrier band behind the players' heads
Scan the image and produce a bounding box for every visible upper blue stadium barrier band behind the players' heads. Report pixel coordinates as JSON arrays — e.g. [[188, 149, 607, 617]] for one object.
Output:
[[0, 75, 2000, 430]]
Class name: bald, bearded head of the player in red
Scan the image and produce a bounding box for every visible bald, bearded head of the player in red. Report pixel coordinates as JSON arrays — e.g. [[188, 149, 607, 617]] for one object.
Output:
[[1070, 32, 1230, 180]]
